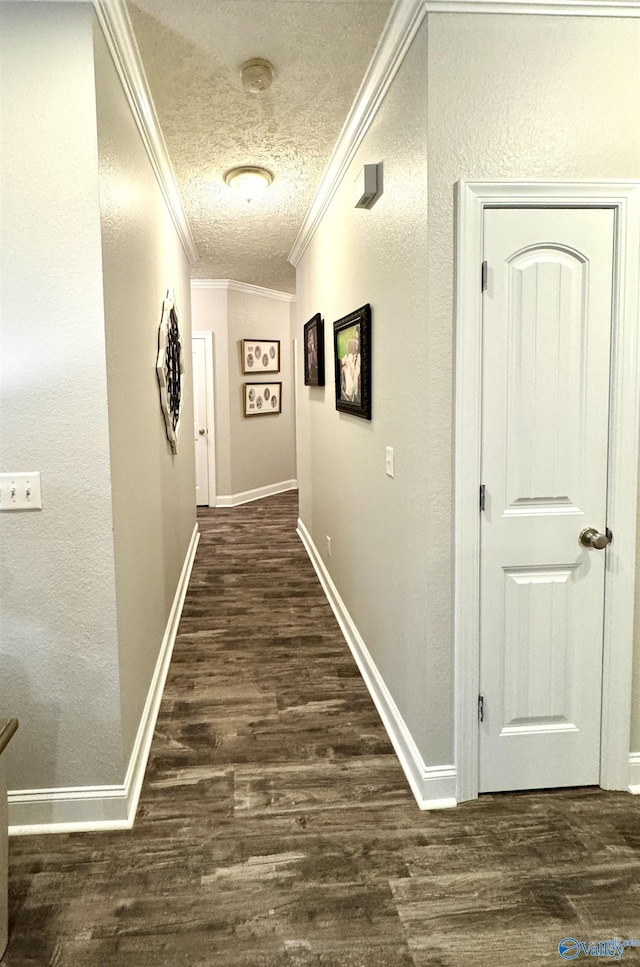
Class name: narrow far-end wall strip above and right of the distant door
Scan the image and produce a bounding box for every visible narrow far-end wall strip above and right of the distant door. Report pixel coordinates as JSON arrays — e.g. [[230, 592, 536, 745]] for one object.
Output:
[[191, 285, 232, 494]]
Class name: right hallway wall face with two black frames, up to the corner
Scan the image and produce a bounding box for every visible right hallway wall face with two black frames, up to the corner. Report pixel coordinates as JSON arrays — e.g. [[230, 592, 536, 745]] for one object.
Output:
[[298, 20, 442, 765]]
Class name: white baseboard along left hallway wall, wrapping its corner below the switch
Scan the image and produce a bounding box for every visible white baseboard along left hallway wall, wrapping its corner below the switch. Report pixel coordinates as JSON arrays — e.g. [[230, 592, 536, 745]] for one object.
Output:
[[8, 524, 200, 836]]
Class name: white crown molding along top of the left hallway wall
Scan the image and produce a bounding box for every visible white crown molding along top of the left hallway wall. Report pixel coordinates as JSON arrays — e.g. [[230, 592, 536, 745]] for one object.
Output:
[[93, 0, 199, 265]]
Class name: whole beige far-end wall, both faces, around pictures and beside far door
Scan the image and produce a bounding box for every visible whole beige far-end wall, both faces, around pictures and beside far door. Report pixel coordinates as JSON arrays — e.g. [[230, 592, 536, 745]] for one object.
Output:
[[192, 282, 296, 498]]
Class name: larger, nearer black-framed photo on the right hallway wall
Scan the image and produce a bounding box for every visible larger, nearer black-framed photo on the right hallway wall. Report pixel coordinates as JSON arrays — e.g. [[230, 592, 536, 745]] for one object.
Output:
[[333, 303, 371, 420]]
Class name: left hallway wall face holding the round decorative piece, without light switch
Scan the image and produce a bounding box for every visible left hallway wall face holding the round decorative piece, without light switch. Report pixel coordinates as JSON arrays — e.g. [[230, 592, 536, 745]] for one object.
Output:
[[95, 25, 195, 761]]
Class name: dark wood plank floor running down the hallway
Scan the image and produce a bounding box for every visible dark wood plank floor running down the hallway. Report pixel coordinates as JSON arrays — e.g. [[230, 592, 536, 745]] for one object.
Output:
[[3, 494, 640, 967]]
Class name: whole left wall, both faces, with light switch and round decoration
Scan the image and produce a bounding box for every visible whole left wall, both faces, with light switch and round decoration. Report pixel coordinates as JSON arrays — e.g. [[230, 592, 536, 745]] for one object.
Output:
[[0, 2, 195, 832]]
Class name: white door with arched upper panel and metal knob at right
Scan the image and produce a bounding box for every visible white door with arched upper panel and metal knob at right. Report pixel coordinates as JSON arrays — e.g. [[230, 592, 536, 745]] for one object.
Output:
[[479, 208, 614, 792]]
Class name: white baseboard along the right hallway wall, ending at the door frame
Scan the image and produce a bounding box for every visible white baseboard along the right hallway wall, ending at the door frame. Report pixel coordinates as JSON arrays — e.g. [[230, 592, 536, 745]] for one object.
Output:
[[298, 520, 457, 809]]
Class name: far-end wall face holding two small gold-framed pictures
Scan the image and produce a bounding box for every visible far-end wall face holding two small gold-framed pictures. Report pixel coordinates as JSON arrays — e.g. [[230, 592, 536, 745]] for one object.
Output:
[[227, 289, 296, 494]]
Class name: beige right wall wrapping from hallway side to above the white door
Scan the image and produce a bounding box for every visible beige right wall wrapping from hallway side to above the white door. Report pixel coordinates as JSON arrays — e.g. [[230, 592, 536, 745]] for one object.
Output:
[[297, 14, 640, 766]]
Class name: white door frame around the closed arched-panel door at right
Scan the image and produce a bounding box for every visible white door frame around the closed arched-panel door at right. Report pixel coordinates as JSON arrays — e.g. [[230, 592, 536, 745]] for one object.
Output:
[[454, 181, 640, 802]]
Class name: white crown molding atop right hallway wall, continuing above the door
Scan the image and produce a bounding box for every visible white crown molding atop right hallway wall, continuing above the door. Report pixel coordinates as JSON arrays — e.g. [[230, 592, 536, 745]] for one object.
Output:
[[289, 0, 640, 266]]
